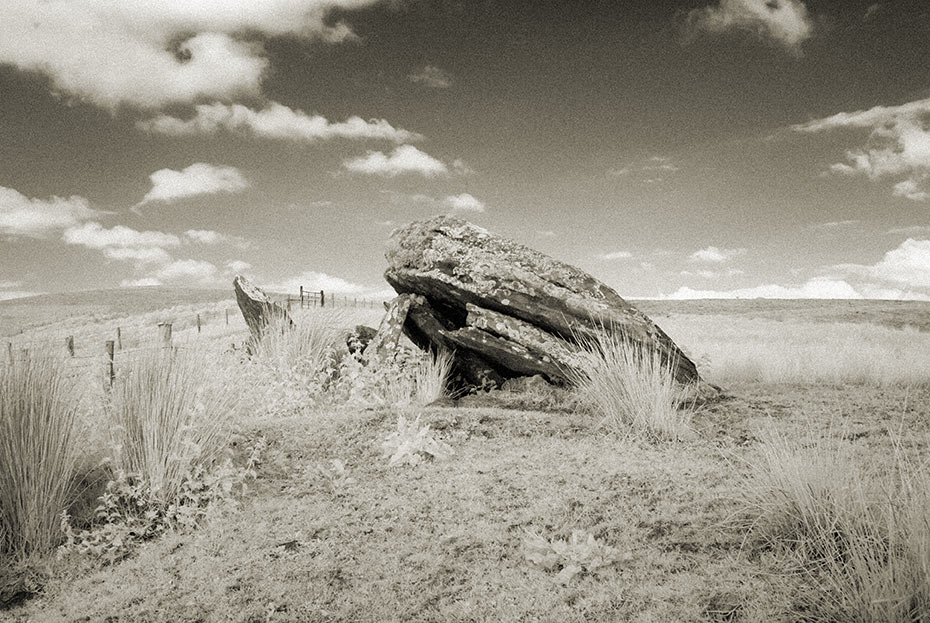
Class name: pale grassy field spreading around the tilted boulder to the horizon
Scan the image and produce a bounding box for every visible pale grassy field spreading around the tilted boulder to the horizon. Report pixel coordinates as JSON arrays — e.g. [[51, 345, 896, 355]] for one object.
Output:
[[0, 292, 930, 622]]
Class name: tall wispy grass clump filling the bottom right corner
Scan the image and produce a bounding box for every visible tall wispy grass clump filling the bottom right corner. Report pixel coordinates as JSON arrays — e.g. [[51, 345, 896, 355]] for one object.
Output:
[[744, 426, 930, 623]]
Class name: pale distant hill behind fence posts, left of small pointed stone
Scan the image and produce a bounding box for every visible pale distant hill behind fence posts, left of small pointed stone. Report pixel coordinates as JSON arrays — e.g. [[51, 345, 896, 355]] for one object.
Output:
[[0, 286, 235, 336]]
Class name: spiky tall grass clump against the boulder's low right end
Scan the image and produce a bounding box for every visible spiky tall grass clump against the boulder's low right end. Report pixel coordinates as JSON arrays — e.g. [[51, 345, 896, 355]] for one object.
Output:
[[571, 328, 694, 439]]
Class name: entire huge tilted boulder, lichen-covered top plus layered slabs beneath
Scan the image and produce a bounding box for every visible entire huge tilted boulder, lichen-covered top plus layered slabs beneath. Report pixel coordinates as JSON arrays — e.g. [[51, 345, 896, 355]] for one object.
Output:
[[384, 216, 700, 385]]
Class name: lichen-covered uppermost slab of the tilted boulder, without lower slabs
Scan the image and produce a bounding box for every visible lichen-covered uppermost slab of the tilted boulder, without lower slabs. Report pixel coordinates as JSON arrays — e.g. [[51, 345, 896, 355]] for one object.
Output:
[[384, 216, 700, 383]]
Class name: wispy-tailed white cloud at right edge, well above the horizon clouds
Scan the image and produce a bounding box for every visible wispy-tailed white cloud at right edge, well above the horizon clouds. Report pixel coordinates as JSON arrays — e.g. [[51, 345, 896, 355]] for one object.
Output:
[[791, 98, 930, 201]]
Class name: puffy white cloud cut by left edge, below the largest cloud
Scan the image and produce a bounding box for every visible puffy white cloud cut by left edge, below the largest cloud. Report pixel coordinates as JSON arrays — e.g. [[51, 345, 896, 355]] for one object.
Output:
[[0, 186, 100, 238]]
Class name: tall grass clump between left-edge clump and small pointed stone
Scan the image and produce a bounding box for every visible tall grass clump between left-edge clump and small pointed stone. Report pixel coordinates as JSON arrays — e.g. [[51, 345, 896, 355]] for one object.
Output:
[[106, 349, 236, 503]]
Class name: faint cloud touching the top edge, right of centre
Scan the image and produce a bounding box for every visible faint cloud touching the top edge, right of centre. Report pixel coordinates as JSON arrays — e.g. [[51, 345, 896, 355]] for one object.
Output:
[[686, 0, 814, 55]]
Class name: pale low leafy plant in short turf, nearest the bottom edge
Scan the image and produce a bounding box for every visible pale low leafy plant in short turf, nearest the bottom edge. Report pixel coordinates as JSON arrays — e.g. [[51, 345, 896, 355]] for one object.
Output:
[[523, 530, 623, 584]]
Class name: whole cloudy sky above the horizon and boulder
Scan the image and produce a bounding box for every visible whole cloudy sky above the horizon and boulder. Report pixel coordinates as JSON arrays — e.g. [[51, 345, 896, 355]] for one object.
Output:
[[0, 0, 930, 300]]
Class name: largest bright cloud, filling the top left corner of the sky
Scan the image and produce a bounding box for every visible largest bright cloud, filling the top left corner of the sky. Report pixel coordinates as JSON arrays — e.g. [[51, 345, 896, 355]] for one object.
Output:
[[0, 0, 377, 109]]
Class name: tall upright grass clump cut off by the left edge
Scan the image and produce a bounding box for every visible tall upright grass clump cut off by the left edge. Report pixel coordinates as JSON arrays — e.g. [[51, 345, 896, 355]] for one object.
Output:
[[0, 354, 79, 558]]
